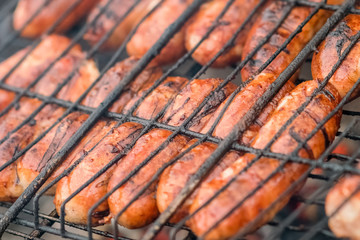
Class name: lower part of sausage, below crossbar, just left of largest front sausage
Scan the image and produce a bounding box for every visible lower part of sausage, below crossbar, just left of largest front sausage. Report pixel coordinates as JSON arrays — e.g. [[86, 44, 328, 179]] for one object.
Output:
[[156, 139, 240, 223]]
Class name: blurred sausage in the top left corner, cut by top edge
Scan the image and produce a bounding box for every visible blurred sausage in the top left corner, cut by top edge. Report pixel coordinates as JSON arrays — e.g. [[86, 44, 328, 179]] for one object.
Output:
[[13, 0, 99, 38]]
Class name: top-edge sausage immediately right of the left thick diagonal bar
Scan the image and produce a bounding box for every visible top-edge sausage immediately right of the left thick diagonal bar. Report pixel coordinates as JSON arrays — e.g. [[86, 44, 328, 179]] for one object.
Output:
[[185, 0, 260, 67]]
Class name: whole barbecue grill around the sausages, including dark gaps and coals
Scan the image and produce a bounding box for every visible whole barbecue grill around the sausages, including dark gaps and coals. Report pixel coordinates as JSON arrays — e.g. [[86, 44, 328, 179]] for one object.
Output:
[[0, 0, 360, 239]]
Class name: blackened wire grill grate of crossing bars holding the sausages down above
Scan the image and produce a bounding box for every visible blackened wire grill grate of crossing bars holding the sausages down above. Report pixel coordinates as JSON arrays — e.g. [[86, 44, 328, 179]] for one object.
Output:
[[0, 0, 360, 239]]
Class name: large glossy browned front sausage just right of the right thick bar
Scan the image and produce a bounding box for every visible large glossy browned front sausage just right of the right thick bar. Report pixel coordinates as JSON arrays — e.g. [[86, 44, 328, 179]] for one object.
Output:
[[189, 81, 341, 239]]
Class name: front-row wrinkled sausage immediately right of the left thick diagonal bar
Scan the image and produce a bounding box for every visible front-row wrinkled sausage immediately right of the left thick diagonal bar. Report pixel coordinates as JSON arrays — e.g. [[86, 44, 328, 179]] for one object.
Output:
[[55, 74, 186, 225]]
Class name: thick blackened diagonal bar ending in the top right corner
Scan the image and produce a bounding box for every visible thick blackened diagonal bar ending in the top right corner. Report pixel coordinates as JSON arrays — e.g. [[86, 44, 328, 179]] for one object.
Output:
[[144, 1, 354, 239]]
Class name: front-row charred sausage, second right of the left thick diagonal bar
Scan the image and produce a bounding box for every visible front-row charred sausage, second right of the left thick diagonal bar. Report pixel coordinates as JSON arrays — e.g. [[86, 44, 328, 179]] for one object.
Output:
[[108, 79, 235, 228]]
